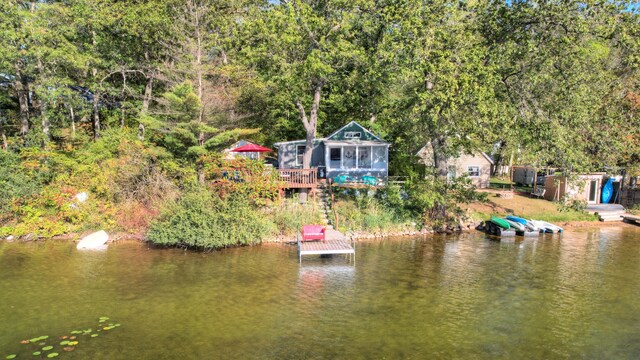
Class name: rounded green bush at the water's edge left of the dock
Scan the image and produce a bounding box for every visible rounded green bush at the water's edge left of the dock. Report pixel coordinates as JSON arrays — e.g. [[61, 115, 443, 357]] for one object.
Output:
[[146, 189, 269, 250]]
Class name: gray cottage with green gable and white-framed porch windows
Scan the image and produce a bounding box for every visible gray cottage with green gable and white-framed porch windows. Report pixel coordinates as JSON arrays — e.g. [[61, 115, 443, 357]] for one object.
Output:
[[273, 121, 389, 180]]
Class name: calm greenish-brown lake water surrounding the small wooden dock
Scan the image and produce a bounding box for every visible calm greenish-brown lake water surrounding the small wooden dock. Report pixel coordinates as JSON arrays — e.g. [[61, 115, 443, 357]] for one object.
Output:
[[0, 227, 640, 359]]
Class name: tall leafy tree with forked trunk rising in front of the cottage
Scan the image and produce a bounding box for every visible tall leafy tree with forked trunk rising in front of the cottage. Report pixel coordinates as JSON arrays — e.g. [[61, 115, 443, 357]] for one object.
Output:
[[245, 0, 358, 202]]
